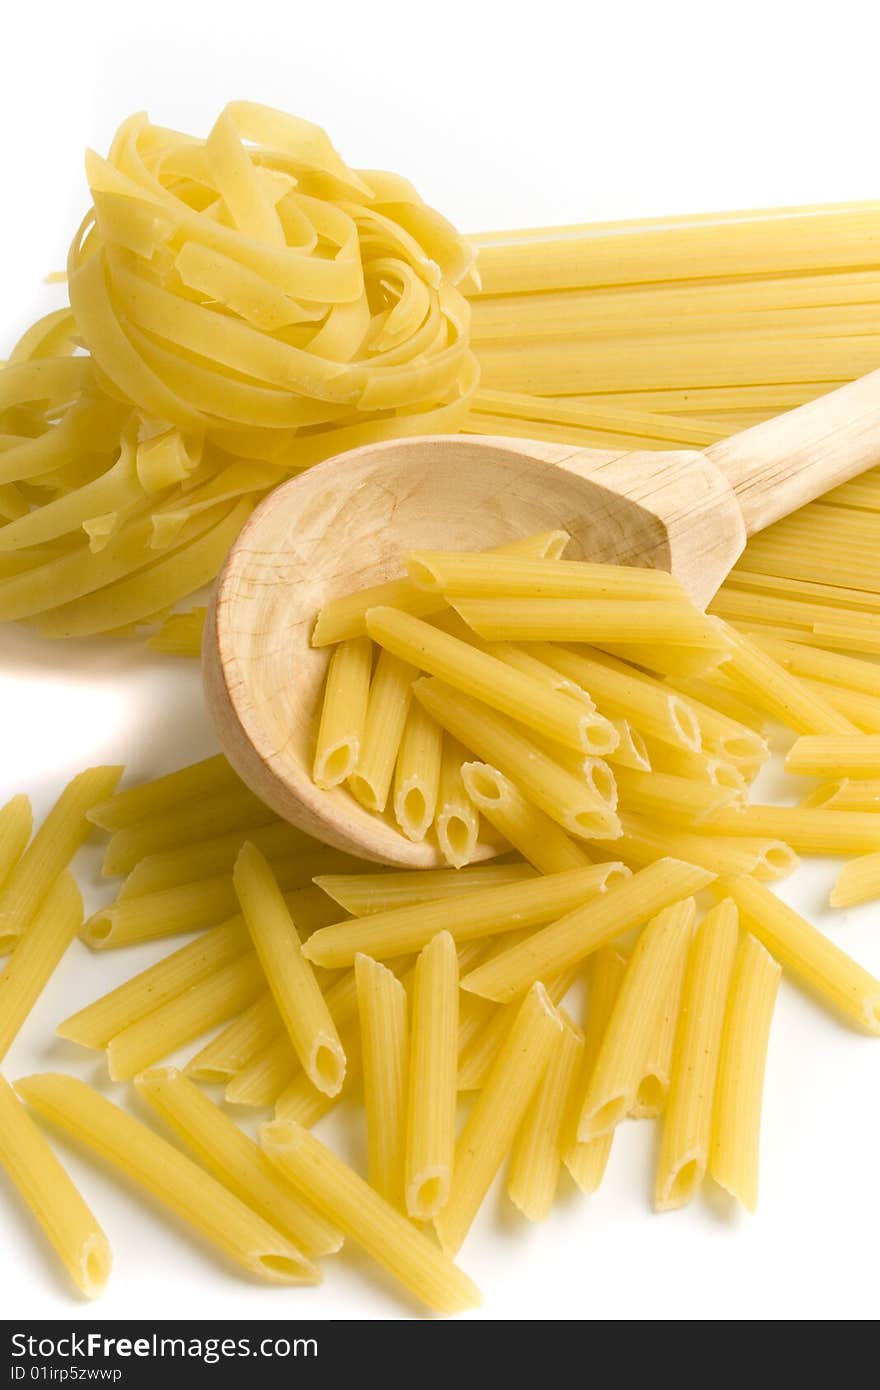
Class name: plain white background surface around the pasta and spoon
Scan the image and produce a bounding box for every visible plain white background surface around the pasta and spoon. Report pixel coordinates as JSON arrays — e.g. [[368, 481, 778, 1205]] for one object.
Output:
[[0, 0, 880, 1319]]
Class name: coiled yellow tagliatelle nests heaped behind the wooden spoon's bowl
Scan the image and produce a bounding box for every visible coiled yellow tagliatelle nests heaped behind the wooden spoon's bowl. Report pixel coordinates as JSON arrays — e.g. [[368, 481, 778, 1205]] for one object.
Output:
[[0, 101, 478, 637]]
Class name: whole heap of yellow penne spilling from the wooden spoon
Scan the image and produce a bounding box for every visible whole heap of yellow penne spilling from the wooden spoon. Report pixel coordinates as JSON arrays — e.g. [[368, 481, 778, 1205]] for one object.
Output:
[[0, 537, 880, 1312]]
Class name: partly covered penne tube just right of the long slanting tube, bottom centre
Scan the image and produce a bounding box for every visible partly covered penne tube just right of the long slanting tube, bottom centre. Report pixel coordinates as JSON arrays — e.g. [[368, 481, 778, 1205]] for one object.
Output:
[[507, 1009, 584, 1220]]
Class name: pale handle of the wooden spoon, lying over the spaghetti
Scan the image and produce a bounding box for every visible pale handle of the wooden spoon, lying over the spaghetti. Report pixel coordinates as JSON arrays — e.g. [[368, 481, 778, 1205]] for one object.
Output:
[[703, 371, 880, 535]]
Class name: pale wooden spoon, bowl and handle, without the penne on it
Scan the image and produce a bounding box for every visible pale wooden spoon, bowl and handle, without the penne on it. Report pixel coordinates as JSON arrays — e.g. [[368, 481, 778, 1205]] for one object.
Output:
[[203, 371, 880, 867]]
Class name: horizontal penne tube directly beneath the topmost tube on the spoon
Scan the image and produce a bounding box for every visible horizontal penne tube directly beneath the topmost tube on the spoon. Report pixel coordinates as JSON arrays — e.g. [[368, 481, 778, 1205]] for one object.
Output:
[[453, 598, 724, 650]]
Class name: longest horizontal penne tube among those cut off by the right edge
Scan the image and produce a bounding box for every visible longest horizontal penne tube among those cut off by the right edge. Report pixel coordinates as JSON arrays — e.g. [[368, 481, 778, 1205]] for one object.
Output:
[[699, 803, 880, 855]]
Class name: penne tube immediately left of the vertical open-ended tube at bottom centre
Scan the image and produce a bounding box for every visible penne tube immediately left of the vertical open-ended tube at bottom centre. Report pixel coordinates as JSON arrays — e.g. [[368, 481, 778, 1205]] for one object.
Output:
[[355, 955, 410, 1207]]
